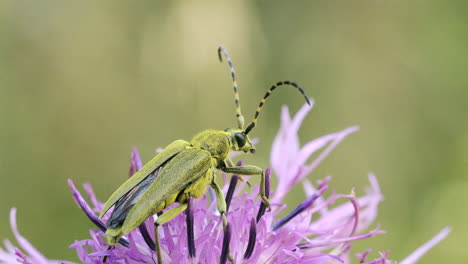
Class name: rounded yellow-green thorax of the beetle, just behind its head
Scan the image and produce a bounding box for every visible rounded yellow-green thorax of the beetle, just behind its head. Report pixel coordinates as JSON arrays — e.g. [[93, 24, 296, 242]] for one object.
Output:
[[190, 130, 232, 161]]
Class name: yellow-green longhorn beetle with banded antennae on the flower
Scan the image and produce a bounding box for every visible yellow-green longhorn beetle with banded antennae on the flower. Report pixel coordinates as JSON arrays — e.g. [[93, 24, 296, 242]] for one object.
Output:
[[99, 46, 310, 264]]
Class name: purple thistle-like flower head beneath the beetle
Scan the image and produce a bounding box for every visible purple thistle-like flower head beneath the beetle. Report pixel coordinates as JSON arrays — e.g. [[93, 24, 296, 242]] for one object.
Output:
[[0, 102, 450, 264]]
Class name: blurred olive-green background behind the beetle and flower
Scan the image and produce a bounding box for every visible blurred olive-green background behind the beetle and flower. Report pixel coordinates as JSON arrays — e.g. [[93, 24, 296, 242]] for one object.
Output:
[[0, 0, 468, 263]]
